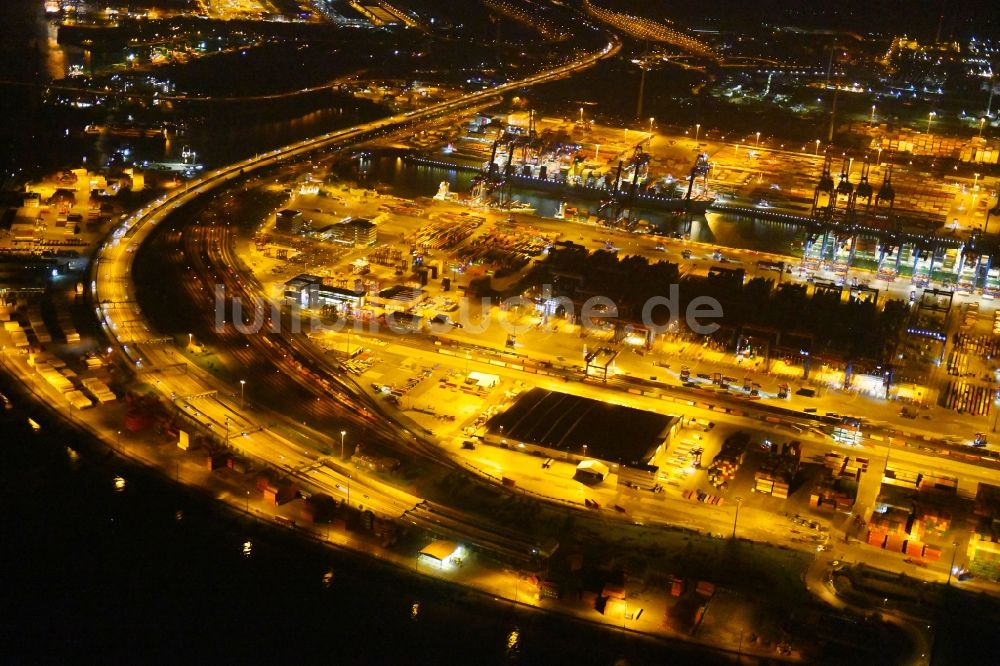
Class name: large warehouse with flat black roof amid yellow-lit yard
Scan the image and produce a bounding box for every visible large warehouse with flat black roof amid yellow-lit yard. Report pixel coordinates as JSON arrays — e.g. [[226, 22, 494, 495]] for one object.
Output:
[[484, 388, 680, 466]]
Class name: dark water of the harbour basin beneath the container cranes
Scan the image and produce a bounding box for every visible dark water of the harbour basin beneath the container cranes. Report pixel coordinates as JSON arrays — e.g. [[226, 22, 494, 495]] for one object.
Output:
[[359, 157, 805, 254]]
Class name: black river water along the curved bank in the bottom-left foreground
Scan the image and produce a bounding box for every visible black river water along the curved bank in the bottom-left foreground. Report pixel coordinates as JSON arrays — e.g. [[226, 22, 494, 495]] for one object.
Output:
[[0, 374, 736, 665]]
